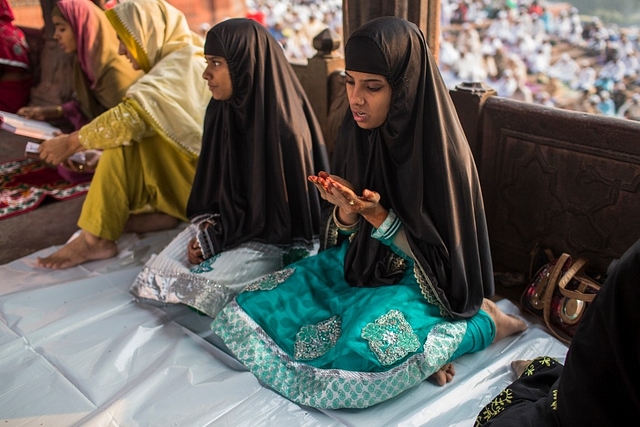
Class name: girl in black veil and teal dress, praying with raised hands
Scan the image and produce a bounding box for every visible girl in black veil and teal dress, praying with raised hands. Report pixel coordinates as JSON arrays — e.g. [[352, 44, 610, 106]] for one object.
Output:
[[212, 17, 526, 408]]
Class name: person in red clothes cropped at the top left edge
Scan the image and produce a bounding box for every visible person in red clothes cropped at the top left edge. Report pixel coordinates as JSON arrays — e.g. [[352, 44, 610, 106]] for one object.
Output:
[[0, 0, 33, 113]]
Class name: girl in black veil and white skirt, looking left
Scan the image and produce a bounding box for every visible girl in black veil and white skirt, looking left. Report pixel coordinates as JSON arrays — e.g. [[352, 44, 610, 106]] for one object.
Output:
[[132, 19, 328, 316]]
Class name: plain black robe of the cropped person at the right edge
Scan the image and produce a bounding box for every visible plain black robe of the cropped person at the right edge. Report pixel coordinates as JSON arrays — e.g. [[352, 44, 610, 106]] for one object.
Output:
[[558, 240, 640, 426]]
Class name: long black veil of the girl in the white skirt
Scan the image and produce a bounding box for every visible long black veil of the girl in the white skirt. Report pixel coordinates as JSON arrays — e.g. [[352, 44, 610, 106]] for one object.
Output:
[[187, 19, 328, 252]]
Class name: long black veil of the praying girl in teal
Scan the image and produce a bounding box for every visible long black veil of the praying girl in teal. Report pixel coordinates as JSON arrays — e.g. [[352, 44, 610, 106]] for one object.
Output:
[[325, 17, 494, 318]]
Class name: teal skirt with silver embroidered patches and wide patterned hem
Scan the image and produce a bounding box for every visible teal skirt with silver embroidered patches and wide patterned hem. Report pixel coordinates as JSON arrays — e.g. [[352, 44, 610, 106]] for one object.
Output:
[[212, 242, 495, 408]]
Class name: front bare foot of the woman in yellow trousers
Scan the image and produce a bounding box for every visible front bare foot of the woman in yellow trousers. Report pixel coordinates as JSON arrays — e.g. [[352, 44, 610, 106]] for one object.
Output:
[[37, 230, 118, 270]]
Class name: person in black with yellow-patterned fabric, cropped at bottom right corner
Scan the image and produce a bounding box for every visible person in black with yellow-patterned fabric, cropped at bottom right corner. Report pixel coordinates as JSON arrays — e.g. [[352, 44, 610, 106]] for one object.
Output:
[[475, 240, 640, 427]]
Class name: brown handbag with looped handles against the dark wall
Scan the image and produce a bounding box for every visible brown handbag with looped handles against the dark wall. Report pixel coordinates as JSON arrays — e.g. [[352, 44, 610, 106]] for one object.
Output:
[[520, 251, 600, 343]]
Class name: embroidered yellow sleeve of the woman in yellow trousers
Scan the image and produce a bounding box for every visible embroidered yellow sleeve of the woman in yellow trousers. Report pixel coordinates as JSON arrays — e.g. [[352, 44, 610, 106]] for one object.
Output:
[[78, 99, 155, 150]]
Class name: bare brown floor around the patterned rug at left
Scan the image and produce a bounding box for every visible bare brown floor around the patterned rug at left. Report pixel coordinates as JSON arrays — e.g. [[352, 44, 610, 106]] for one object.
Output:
[[0, 129, 85, 264]]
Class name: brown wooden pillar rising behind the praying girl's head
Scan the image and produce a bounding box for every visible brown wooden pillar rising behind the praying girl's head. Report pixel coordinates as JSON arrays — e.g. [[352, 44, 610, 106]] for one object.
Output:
[[342, 0, 440, 60]]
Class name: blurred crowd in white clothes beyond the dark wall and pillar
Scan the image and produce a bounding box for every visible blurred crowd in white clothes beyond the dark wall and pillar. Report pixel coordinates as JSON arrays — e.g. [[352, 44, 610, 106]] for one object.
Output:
[[244, 0, 640, 120]]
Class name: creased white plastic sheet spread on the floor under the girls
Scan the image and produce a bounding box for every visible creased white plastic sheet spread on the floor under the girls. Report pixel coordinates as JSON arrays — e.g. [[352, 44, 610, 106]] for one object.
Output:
[[0, 230, 567, 427]]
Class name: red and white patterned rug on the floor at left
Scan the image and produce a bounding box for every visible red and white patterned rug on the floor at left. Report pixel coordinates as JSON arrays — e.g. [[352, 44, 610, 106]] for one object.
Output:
[[0, 159, 90, 219]]
